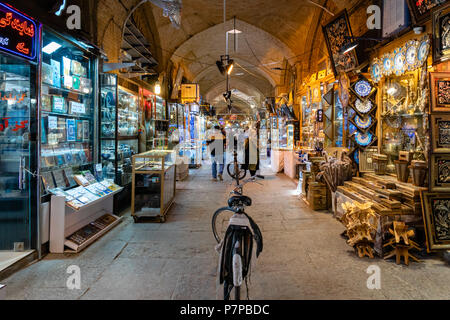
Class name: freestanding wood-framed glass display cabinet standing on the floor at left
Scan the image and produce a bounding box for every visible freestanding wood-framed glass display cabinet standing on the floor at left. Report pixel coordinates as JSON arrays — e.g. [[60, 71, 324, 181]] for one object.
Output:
[[131, 150, 176, 222]]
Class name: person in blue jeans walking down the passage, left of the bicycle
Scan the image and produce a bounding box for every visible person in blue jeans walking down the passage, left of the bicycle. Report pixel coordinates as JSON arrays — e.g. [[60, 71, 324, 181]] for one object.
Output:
[[206, 125, 226, 181]]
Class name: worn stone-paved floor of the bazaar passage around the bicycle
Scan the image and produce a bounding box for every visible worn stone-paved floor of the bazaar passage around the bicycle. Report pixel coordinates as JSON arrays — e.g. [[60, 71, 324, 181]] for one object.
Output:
[[2, 162, 450, 299]]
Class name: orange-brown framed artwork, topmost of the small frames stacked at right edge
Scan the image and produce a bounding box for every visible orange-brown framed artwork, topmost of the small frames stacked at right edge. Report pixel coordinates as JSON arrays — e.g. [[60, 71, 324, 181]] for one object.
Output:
[[430, 72, 450, 113]]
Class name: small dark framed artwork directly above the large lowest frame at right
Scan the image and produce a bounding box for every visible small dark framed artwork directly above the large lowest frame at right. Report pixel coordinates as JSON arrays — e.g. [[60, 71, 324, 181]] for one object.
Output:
[[430, 154, 450, 192]]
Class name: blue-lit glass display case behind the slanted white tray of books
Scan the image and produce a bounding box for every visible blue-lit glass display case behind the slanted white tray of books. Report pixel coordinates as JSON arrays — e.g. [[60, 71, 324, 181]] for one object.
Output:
[[40, 29, 98, 193]]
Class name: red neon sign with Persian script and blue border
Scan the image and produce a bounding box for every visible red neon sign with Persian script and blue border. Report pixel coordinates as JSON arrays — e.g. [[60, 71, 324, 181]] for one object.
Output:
[[0, 3, 39, 60]]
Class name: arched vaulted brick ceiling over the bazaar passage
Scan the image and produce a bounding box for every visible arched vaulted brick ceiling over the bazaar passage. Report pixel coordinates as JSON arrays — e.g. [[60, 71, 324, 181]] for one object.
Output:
[[139, 0, 359, 112]]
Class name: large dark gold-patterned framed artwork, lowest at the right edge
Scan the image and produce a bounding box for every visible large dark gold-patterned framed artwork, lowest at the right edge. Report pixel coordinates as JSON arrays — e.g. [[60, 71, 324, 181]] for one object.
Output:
[[421, 192, 450, 252]]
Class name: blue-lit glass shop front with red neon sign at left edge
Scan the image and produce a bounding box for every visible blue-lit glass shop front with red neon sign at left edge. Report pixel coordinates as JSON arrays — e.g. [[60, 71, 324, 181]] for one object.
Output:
[[0, 3, 41, 272]]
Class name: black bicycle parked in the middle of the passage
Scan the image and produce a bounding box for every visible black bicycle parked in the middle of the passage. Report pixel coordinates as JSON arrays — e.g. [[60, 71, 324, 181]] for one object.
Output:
[[212, 151, 264, 300]]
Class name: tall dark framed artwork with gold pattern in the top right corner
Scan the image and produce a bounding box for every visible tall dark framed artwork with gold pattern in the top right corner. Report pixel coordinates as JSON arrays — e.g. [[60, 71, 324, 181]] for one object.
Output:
[[432, 3, 450, 64]]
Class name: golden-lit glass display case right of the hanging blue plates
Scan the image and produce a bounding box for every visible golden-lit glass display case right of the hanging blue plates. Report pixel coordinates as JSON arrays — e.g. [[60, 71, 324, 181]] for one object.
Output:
[[381, 71, 425, 173]]
